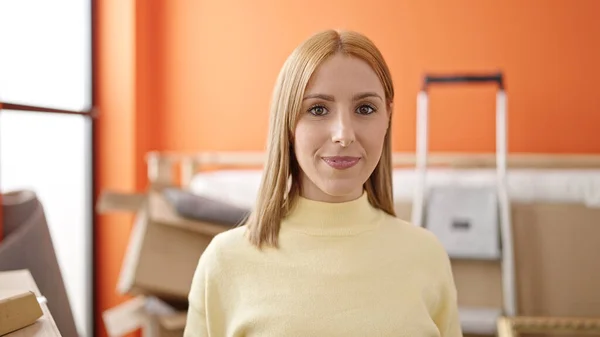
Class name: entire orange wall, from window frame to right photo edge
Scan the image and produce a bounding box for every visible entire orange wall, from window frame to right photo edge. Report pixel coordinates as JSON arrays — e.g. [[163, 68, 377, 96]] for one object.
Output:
[[95, 0, 600, 336]]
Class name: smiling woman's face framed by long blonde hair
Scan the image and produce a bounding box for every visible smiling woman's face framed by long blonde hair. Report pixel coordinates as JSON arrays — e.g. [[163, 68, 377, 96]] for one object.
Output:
[[294, 54, 390, 202]]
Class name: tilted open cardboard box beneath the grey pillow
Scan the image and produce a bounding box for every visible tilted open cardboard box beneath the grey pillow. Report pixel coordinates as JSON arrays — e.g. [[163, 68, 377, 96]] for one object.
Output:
[[97, 190, 228, 301]]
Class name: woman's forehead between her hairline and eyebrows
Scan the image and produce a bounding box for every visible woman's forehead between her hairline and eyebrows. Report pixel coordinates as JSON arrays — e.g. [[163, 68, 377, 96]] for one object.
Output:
[[305, 54, 384, 97]]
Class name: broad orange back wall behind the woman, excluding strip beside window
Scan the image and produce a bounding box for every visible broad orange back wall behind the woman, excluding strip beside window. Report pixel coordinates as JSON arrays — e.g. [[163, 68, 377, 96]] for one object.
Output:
[[159, 0, 600, 153]]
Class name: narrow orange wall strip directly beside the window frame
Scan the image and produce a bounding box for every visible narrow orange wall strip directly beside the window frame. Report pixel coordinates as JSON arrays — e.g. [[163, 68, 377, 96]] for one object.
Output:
[[94, 0, 138, 336]]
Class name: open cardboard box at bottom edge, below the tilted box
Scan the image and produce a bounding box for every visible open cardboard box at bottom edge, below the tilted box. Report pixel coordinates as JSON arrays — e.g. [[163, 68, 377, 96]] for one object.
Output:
[[102, 296, 187, 337]]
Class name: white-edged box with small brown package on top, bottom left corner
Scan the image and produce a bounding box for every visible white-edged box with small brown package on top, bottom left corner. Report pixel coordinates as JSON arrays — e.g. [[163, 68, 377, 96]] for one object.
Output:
[[0, 270, 60, 337]]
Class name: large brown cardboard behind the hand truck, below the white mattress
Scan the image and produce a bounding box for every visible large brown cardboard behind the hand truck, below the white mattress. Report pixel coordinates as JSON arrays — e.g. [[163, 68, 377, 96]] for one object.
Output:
[[396, 202, 600, 317]]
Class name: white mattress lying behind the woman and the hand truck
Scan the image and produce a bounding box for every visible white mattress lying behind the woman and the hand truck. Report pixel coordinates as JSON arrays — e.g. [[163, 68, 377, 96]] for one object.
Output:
[[190, 168, 600, 208]]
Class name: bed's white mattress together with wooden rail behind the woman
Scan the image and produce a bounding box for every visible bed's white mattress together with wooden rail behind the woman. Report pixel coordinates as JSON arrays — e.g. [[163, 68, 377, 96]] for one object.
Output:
[[147, 152, 600, 207]]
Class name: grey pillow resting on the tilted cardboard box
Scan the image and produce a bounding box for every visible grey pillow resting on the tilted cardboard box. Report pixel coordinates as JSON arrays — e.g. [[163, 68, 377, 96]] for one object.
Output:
[[162, 187, 250, 226]]
